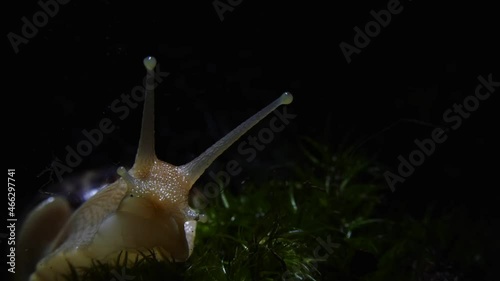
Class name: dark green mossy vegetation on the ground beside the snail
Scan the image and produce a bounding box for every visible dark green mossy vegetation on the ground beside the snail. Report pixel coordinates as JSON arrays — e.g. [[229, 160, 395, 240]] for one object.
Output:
[[68, 139, 494, 281]]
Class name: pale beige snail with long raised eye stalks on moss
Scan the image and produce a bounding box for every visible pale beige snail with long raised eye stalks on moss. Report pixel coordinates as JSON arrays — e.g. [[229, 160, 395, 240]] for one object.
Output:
[[19, 57, 293, 281]]
